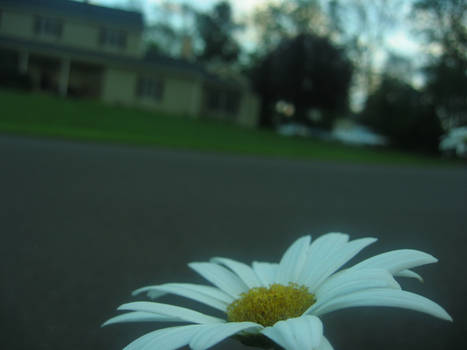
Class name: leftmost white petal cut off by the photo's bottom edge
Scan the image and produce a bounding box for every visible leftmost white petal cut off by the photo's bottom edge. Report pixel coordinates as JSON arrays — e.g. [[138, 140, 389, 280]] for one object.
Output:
[[123, 324, 205, 350]]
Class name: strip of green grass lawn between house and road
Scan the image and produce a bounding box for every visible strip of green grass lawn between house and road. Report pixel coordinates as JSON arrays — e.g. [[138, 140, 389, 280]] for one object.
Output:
[[0, 90, 457, 165]]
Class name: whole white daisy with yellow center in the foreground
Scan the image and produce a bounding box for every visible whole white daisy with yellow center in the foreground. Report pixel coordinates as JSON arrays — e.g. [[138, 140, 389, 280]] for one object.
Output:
[[103, 233, 452, 350]]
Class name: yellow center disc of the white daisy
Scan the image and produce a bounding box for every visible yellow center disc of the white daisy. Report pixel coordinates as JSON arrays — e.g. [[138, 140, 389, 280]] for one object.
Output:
[[227, 283, 316, 327]]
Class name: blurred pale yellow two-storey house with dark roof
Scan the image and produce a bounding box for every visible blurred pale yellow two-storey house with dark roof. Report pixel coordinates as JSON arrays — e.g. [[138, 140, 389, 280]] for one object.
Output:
[[0, 0, 258, 126]]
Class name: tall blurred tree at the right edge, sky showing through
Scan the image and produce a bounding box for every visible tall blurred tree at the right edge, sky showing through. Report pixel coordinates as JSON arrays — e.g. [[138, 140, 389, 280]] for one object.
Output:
[[414, 0, 467, 129]]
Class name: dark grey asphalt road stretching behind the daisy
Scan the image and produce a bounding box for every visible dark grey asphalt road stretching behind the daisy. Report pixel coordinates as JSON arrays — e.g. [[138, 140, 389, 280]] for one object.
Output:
[[0, 136, 467, 350]]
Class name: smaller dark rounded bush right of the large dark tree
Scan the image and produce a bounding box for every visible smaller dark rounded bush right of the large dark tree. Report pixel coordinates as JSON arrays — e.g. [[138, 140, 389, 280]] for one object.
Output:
[[362, 77, 442, 153]]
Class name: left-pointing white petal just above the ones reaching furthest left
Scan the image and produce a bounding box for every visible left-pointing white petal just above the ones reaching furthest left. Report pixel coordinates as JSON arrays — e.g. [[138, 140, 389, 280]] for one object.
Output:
[[132, 283, 234, 311]]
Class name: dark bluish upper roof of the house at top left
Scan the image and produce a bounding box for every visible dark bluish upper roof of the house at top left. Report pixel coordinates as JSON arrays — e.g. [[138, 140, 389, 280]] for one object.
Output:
[[0, 0, 144, 29]]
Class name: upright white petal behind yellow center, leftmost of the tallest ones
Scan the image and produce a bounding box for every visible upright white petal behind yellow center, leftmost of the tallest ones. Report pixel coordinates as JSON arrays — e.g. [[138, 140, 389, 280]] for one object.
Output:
[[276, 236, 311, 285]]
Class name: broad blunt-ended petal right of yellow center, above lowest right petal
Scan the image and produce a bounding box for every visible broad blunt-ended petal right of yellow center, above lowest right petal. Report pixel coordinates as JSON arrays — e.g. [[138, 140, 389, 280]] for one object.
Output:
[[306, 269, 400, 314]]
